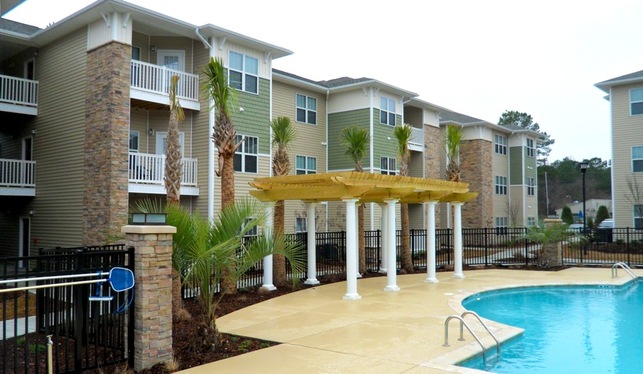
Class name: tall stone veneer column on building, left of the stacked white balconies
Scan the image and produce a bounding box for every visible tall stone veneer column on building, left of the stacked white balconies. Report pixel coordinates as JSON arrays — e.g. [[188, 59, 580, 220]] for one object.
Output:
[[83, 42, 131, 244]]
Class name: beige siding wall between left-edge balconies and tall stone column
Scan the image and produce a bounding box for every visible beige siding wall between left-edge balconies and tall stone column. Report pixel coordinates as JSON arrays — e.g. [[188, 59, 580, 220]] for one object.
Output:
[[32, 28, 87, 247]]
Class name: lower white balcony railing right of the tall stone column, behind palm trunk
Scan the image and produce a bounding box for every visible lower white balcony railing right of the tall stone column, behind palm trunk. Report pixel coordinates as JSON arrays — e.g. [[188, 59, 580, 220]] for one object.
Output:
[[128, 152, 198, 187]]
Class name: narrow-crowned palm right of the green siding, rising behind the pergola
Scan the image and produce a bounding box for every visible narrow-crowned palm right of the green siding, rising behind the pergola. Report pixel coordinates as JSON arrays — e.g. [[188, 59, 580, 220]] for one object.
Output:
[[393, 123, 414, 274]]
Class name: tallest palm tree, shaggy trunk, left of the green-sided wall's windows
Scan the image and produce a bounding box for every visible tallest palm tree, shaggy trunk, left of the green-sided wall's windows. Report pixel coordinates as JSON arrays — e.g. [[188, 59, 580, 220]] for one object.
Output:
[[205, 57, 241, 293]]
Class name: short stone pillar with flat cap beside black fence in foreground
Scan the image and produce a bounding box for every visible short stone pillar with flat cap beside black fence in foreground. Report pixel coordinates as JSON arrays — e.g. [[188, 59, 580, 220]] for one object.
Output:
[[121, 225, 176, 371]]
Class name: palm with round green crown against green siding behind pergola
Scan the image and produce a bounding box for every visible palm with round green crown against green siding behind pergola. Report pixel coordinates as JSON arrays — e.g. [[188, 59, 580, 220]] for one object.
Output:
[[341, 126, 371, 273]]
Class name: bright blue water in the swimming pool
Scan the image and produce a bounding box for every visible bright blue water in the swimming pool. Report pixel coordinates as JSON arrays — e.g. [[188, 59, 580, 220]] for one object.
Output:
[[461, 281, 643, 374]]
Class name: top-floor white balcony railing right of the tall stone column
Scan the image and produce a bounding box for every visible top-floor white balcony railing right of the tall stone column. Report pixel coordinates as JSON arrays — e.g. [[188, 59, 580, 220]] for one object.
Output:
[[131, 60, 199, 101]]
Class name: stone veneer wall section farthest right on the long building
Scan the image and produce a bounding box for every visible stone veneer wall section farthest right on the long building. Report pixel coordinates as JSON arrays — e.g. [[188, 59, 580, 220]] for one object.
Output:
[[460, 139, 494, 228]]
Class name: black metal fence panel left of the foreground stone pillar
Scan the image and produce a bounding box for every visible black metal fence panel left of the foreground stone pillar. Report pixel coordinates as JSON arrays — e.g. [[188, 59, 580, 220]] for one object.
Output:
[[0, 245, 134, 374]]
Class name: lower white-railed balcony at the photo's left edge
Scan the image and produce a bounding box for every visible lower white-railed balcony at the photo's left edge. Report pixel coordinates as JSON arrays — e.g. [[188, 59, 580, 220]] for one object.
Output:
[[0, 158, 36, 197]]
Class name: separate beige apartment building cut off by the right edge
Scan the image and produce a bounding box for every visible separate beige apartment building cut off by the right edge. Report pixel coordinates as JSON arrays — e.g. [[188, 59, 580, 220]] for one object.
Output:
[[596, 70, 643, 229]]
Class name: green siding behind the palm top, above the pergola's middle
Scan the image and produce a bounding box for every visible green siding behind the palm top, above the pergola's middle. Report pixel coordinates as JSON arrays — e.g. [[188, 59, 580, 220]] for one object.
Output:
[[328, 108, 371, 171]]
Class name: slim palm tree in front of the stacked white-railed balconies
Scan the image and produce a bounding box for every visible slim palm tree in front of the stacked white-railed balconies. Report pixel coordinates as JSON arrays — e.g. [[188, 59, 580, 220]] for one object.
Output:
[[165, 75, 185, 315]]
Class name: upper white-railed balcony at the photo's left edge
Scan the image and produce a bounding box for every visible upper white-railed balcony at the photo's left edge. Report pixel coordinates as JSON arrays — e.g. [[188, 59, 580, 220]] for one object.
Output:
[[0, 75, 38, 116]]
